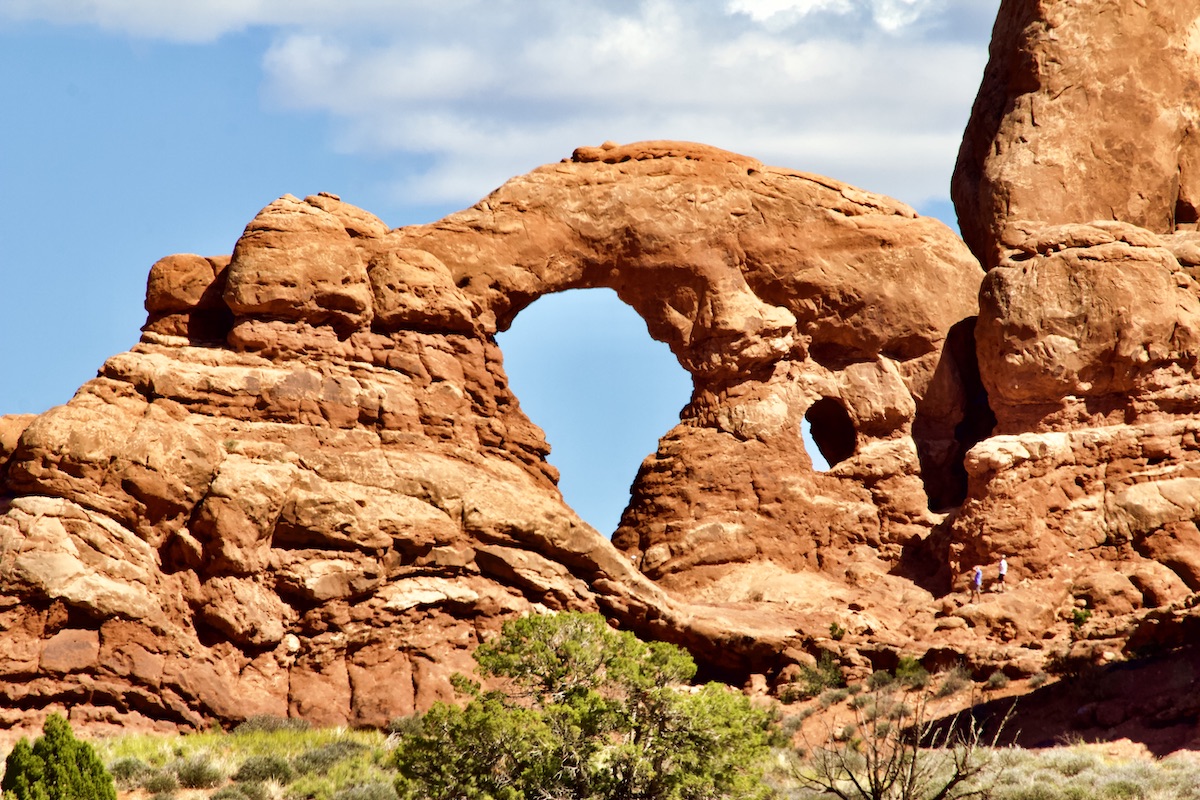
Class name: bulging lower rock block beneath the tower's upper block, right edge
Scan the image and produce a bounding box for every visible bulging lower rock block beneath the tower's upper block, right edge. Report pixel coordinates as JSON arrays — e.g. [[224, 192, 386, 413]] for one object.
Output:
[[954, 221, 1200, 615]]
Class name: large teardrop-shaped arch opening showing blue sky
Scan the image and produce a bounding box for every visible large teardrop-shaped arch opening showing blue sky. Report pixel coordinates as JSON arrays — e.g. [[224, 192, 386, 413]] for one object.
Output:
[[497, 289, 692, 536]]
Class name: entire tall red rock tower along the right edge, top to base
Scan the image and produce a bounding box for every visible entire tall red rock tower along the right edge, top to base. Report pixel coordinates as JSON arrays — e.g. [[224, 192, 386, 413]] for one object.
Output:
[[946, 0, 1200, 663]]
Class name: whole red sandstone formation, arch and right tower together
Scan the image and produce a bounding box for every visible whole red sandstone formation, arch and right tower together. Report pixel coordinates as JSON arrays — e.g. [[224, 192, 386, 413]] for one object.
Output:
[[0, 0, 1200, 743]]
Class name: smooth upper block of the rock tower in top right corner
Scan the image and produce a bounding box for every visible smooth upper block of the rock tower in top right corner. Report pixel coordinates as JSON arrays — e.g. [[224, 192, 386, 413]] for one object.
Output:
[[950, 0, 1200, 267]]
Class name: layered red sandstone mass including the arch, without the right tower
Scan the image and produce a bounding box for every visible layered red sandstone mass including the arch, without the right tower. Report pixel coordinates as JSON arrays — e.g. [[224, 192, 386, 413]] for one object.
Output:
[[0, 143, 982, 726]]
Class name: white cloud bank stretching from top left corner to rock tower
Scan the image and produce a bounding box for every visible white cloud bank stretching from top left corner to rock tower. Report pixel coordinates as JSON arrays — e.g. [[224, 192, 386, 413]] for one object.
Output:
[[0, 0, 998, 212]]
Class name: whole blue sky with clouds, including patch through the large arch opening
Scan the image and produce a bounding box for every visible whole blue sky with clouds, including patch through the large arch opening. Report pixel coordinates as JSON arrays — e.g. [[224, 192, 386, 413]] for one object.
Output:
[[0, 0, 998, 533]]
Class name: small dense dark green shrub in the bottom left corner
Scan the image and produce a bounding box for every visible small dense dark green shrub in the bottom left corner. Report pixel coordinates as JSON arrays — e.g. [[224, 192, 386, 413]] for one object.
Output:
[[0, 714, 116, 800]]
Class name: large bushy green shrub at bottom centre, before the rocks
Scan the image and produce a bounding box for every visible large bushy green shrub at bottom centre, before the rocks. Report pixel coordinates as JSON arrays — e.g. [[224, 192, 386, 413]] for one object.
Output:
[[395, 614, 776, 800]]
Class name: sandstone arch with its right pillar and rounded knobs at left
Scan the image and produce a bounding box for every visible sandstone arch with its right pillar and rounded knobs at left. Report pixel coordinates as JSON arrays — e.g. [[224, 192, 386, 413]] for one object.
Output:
[[140, 142, 982, 587]]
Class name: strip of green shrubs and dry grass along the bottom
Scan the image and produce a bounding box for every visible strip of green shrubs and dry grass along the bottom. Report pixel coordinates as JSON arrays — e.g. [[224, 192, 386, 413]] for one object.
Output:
[[2, 614, 1200, 800]]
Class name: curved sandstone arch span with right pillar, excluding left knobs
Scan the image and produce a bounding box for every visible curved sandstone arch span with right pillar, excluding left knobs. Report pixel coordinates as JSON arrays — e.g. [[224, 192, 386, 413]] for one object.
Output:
[[396, 142, 982, 576]]
